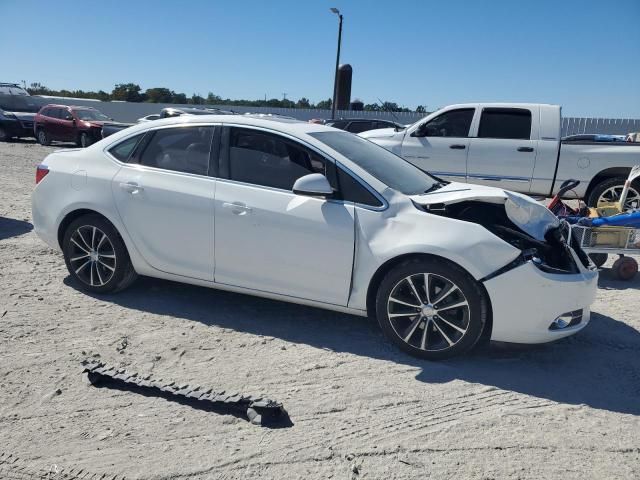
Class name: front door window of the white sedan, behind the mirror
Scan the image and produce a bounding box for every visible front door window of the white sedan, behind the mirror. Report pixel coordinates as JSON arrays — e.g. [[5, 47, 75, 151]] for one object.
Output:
[[229, 128, 326, 190]]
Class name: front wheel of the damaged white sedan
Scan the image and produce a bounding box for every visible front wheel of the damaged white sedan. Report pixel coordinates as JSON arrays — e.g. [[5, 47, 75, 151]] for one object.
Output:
[[376, 258, 489, 360]]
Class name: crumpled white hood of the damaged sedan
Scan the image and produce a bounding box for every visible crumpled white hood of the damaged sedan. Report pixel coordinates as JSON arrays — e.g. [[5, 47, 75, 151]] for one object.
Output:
[[411, 182, 560, 241]]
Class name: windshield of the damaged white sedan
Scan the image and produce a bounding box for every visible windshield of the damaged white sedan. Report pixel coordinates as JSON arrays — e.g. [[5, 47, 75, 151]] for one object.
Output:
[[309, 132, 438, 195]]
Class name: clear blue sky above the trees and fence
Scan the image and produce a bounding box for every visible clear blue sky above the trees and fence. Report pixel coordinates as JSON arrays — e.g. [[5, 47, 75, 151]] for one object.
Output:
[[0, 0, 640, 118]]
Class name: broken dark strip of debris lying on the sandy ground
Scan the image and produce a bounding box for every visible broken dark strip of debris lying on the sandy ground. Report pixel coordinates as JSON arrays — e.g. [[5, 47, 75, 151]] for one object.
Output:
[[82, 359, 290, 426]]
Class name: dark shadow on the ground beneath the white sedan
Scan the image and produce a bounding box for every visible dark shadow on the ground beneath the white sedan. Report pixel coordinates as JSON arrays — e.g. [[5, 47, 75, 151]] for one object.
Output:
[[65, 277, 640, 415]]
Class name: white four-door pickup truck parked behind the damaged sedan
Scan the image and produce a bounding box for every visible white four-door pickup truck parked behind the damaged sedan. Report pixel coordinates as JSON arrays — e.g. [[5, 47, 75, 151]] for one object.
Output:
[[360, 103, 640, 207]]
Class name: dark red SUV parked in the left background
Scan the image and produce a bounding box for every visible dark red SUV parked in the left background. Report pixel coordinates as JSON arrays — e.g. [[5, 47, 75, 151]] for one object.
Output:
[[33, 105, 114, 147]]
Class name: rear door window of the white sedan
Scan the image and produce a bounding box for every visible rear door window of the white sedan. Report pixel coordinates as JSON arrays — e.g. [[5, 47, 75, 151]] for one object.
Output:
[[140, 127, 214, 175]]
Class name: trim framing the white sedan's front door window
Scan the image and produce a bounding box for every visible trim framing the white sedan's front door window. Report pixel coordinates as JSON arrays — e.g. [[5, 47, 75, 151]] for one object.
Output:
[[218, 123, 389, 211]]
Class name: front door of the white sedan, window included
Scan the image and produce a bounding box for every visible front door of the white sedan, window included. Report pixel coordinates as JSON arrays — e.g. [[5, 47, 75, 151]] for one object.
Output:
[[215, 127, 354, 305]]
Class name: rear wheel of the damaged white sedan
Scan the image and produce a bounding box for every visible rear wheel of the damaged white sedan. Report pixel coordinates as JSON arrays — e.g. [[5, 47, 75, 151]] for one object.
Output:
[[62, 214, 137, 293]]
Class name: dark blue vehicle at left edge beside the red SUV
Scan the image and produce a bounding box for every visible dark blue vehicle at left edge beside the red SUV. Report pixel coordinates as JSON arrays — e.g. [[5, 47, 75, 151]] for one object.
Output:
[[0, 83, 42, 142]]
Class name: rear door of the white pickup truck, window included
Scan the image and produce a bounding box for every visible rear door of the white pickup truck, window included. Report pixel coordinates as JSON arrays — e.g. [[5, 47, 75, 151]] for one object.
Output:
[[467, 107, 539, 193]]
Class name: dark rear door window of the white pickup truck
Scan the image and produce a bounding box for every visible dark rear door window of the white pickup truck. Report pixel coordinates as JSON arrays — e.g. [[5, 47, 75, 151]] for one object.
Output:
[[478, 108, 531, 140]]
